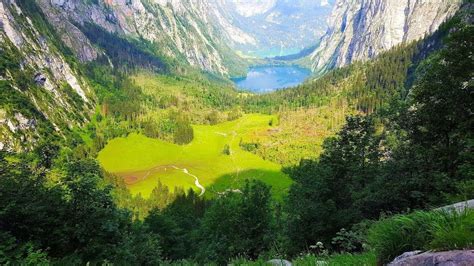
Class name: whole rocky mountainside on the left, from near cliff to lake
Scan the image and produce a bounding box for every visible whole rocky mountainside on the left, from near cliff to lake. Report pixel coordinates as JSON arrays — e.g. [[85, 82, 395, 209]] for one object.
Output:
[[0, 0, 252, 151]]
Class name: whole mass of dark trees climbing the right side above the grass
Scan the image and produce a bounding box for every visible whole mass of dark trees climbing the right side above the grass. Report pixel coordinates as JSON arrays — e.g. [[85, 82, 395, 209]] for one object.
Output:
[[287, 9, 474, 255]]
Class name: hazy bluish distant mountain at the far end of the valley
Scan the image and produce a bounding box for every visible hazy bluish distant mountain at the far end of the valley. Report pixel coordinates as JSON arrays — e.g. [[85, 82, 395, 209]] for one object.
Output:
[[215, 0, 334, 57]]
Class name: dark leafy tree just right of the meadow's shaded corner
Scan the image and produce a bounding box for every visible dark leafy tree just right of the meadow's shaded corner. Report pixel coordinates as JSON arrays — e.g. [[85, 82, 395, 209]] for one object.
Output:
[[287, 117, 379, 255]]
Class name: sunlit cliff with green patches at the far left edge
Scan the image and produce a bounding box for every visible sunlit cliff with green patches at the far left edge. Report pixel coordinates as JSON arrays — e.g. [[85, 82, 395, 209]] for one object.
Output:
[[0, 0, 94, 151]]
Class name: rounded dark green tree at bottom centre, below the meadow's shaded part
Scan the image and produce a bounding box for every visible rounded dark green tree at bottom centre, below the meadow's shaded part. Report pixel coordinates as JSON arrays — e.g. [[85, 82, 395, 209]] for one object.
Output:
[[197, 181, 273, 264]]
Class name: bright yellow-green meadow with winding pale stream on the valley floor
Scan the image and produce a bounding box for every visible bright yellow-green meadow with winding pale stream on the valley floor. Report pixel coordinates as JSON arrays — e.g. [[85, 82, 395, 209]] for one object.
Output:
[[98, 114, 291, 198]]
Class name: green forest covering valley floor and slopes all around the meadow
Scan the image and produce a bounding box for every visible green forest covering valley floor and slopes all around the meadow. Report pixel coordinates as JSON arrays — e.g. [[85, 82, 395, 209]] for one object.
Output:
[[0, 1, 474, 265]]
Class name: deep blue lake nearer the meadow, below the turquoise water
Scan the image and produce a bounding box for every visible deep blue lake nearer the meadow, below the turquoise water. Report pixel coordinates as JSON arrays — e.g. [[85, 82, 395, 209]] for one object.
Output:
[[232, 66, 311, 93]]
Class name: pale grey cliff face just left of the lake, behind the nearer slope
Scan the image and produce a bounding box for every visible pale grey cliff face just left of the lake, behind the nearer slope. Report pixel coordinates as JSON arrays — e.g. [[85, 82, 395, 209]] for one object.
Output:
[[38, 0, 244, 75]]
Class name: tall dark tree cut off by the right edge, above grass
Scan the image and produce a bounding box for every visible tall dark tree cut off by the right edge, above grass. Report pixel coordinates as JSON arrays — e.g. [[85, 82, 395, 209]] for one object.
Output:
[[409, 25, 474, 183]]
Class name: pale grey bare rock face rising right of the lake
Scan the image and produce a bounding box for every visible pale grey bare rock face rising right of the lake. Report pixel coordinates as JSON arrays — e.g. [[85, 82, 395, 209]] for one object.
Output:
[[309, 0, 460, 73]]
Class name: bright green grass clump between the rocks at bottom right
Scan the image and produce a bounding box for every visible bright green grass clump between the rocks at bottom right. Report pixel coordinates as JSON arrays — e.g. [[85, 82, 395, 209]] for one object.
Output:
[[368, 210, 474, 263]]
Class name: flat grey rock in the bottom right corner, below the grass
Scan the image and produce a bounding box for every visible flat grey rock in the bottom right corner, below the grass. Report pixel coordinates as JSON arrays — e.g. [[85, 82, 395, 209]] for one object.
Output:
[[388, 250, 474, 266]]
